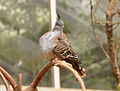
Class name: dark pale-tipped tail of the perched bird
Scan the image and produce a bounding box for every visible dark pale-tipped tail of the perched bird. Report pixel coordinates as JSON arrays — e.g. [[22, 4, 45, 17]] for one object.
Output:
[[65, 57, 86, 77]]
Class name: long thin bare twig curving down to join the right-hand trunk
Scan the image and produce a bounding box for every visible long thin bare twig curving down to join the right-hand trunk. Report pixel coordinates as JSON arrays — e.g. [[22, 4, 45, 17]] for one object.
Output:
[[90, 0, 110, 59]]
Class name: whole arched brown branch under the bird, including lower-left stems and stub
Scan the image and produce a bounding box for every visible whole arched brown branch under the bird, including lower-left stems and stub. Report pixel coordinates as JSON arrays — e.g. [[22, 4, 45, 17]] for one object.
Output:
[[0, 60, 86, 91]]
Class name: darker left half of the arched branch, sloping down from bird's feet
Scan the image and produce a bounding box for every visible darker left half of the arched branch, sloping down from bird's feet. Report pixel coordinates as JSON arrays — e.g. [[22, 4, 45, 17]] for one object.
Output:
[[31, 62, 53, 88]]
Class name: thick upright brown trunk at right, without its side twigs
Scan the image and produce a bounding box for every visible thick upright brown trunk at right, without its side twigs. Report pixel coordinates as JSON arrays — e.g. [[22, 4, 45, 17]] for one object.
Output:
[[106, 0, 120, 85]]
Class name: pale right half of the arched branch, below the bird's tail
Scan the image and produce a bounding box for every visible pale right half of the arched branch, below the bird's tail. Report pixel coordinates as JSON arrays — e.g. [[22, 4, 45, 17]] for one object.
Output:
[[55, 61, 86, 91]]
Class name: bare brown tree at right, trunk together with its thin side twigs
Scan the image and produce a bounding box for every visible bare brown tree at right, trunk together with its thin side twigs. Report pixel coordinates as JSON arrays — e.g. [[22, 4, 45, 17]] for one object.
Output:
[[90, 0, 120, 86]]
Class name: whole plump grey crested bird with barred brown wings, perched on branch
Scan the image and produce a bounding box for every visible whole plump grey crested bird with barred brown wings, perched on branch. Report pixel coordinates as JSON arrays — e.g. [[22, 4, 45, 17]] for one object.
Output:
[[38, 12, 86, 77]]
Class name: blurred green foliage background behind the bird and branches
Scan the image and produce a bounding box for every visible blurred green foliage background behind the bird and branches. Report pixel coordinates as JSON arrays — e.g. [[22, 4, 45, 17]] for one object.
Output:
[[0, 0, 120, 89]]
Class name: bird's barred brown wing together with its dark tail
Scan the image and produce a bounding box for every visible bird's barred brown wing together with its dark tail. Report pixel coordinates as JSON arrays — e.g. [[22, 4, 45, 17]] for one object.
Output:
[[53, 37, 85, 77]]
